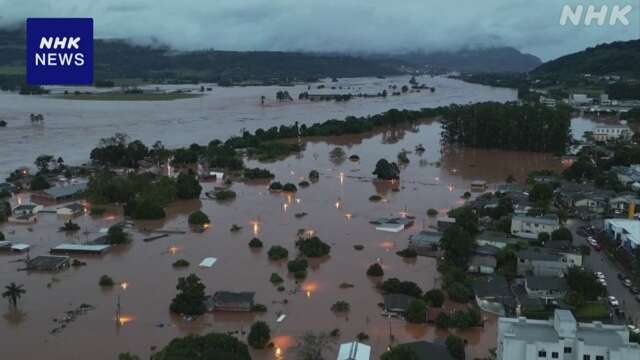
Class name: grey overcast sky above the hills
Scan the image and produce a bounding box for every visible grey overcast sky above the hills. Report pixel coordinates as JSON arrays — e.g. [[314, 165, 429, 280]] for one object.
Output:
[[0, 0, 640, 60]]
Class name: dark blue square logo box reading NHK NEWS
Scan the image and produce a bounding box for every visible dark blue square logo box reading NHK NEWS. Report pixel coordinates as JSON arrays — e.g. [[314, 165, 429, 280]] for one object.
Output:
[[27, 18, 93, 85]]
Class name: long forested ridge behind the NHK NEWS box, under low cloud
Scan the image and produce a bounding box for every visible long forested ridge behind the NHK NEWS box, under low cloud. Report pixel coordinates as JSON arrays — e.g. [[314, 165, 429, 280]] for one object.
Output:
[[0, 30, 398, 83]]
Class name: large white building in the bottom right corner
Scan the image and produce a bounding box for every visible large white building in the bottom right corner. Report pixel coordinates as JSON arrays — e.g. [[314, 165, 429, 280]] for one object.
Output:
[[497, 310, 640, 360]]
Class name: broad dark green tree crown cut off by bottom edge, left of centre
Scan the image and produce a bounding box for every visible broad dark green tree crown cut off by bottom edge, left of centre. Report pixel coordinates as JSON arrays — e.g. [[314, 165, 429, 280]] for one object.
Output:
[[151, 333, 251, 360]]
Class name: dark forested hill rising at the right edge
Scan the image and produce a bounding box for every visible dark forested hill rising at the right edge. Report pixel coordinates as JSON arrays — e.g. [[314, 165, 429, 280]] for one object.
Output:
[[533, 40, 640, 78]]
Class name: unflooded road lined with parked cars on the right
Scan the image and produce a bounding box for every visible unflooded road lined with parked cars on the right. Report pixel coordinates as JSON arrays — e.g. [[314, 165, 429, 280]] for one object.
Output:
[[568, 220, 640, 324]]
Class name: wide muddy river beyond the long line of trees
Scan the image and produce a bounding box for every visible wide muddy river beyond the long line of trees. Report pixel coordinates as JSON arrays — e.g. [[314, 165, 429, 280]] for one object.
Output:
[[0, 76, 516, 178]]
